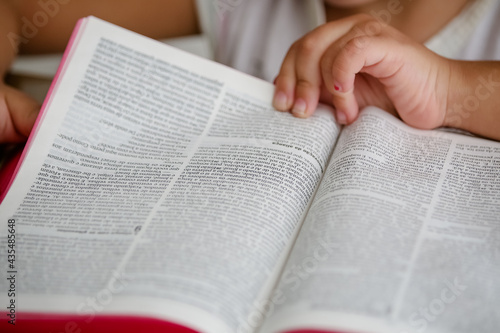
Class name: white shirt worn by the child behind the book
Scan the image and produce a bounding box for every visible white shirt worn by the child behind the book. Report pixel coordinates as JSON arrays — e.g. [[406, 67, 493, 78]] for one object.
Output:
[[197, 0, 500, 81]]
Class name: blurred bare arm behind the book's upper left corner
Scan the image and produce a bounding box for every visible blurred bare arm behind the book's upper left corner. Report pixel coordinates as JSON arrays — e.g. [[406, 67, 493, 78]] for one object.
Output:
[[17, 0, 199, 53]]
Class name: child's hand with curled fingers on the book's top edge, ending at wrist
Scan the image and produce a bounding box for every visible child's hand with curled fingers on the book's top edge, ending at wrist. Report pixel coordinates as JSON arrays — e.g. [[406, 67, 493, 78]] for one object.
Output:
[[274, 15, 452, 129]]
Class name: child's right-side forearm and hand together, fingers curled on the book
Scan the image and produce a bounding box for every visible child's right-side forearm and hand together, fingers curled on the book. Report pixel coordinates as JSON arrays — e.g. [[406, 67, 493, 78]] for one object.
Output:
[[274, 15, 500, 140]]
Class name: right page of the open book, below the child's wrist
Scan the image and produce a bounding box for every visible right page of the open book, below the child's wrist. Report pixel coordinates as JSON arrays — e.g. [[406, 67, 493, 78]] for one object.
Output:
[[262, 108, 500, 333]]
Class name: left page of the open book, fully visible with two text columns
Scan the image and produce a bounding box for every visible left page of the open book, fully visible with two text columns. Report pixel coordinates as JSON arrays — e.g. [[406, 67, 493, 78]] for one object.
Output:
[[0, 18, 339, 333]]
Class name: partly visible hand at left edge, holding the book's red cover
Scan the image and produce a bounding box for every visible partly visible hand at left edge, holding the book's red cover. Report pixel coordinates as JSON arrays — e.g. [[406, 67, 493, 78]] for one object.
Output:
[[0, 82, 40, 143]]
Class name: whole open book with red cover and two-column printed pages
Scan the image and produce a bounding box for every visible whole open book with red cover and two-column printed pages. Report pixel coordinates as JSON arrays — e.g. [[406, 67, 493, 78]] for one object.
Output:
[[0, 17, 500, 333]]
